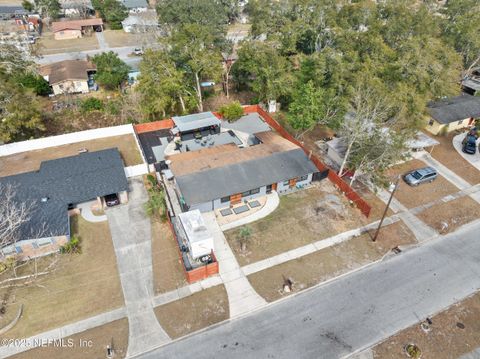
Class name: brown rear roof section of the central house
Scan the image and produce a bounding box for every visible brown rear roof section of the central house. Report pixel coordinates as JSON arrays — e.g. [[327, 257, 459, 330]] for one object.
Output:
[[166, 131, 299, 177]]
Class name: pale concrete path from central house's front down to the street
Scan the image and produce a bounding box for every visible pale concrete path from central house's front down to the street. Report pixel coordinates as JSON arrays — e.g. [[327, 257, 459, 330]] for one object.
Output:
[[202, 212, 267, 318]]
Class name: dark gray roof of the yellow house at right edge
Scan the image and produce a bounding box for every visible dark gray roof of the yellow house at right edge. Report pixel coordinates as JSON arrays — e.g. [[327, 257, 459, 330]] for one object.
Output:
[[428, 95, 480, 124]]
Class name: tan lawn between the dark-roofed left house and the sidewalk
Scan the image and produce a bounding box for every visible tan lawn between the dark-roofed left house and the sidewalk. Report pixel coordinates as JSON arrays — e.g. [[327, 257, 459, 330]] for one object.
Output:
[[0, 216, 124, 338]]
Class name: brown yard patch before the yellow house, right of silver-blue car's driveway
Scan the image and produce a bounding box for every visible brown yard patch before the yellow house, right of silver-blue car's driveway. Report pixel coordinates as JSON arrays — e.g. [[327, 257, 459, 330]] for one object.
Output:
[[428, 132, 480, 185]]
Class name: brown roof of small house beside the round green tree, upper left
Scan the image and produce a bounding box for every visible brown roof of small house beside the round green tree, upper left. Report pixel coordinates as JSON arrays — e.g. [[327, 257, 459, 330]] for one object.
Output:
[[40, 60, 96, 85]]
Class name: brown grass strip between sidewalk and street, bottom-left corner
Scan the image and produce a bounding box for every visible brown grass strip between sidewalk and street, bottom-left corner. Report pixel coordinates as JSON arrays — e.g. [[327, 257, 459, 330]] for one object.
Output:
[[10, 318, 128, 359]]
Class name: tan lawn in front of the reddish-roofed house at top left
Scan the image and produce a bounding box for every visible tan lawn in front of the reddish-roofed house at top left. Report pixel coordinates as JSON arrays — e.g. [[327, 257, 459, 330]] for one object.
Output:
[[39, 31, 98, 55]]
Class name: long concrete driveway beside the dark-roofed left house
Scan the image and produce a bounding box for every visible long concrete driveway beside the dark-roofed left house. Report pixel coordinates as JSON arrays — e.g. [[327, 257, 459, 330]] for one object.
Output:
[[107, 177, 170, 358]]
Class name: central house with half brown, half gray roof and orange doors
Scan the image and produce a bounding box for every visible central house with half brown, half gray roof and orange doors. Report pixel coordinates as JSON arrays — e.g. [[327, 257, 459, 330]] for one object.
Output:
[[167, 131, 318, 212]]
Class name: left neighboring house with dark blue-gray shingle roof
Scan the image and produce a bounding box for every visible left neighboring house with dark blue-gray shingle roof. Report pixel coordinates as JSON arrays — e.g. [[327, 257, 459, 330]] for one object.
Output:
[[0, 148, 128, 257]]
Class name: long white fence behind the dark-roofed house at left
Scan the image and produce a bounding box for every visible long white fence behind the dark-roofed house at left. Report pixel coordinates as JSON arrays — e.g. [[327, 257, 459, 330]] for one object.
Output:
[[0, 125, 135, 157]]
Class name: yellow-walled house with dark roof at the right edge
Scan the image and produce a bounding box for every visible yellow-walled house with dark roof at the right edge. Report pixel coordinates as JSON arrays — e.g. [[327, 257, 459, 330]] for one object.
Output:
[[426, 95, 480, 135]]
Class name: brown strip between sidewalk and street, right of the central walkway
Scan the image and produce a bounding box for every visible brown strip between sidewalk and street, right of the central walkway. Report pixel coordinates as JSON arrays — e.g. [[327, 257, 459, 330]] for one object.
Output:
[[248, 221, 415, 302]]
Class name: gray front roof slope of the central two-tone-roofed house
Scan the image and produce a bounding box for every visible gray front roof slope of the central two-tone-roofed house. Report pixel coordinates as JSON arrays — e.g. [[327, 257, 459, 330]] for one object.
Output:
[[176, 148, 318, 205]]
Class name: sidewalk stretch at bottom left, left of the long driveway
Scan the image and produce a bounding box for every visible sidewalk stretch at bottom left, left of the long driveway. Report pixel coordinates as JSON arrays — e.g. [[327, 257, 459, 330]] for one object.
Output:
[[0, 307, 127, 358]]
